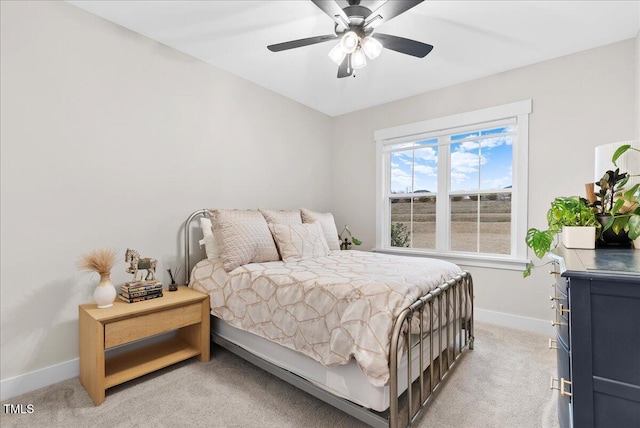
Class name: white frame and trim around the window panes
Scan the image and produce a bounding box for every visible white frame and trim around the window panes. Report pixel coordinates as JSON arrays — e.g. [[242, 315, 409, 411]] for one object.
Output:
[[374, 100, 532, 270]]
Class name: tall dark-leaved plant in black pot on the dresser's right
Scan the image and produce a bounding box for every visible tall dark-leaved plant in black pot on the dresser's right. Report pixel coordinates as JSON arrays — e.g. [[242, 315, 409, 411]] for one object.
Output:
[[592, 144, 640, 245]]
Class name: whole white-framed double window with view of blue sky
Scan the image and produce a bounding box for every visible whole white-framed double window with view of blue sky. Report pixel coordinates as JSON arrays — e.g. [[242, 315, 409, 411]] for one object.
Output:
[[375, 100, 531, 269]]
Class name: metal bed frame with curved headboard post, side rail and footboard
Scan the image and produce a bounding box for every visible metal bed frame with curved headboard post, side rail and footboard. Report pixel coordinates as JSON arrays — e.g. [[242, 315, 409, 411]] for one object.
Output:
[[184, 209, 474, 428]]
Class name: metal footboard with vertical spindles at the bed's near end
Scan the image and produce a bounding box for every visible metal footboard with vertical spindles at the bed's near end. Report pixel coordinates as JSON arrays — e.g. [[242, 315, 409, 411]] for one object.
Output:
[[389, 272, 474, 428]]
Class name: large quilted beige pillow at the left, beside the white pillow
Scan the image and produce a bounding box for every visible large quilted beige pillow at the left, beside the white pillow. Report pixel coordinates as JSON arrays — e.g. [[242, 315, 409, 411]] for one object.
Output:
[[211, 210, 280, 272]]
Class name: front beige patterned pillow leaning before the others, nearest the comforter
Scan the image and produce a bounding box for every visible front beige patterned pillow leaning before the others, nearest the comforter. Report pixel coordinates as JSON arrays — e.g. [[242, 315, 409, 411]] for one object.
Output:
[[269, 223, 329, 262]]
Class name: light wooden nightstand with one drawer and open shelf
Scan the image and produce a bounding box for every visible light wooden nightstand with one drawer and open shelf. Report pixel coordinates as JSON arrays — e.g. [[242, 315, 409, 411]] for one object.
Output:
[[79, 286, 210, 406]]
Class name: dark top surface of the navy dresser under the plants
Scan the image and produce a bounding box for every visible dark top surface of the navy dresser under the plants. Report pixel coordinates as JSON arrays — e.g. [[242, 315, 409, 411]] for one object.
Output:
[[550, 246, 640, 281]]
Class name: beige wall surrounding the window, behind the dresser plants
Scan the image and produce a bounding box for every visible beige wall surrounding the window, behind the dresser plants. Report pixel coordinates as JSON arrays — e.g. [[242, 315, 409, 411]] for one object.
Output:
[[333, 39, 639, 319]]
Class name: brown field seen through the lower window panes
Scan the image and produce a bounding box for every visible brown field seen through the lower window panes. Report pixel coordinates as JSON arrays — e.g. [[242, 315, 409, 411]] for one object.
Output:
[[391, 198, 511, 254]]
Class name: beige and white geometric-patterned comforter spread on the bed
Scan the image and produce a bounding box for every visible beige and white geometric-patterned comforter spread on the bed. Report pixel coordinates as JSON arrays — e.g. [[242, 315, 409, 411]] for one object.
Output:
[[189, 251, 462, 386]]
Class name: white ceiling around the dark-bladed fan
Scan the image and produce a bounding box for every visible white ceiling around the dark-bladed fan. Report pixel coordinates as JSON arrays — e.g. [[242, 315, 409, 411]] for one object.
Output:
[[69, 0, 640, 116]]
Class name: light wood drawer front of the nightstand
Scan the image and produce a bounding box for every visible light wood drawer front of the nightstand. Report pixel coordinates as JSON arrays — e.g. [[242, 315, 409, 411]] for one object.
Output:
[[104, 303, 202, 348]]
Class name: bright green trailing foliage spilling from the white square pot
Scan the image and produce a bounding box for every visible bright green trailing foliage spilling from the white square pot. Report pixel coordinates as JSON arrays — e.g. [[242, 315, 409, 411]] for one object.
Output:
[[522, 196, 600, 277]]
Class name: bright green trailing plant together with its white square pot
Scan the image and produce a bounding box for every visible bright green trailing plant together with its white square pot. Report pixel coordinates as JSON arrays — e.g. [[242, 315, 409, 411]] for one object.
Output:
[[523, 196, 600, 277]]
